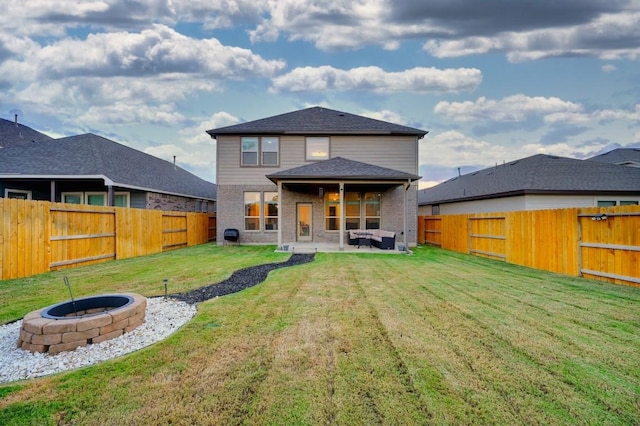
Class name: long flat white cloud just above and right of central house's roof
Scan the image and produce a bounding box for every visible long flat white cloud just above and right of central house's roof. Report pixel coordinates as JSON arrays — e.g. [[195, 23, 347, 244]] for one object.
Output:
[[433, 94, 583, 122]]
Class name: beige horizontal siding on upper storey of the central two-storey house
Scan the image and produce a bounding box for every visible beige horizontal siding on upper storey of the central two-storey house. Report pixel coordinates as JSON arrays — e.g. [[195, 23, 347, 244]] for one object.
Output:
[[216, 136, 418, 185]]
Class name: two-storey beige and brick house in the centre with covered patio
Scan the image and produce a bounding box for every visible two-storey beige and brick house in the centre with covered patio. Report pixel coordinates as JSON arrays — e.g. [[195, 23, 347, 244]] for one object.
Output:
[[207, 107, 427, 248]]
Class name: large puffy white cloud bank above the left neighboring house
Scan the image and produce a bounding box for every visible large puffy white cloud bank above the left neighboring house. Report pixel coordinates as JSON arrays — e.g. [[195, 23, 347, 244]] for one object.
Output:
[[0, 25, 285, 80]]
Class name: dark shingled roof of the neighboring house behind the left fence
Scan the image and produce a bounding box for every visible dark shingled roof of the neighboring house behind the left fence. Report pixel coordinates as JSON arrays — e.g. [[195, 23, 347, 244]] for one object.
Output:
[[0, 133, 216, 200]]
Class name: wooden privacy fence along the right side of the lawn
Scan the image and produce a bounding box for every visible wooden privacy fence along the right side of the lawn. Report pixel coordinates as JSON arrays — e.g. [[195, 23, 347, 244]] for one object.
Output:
[[418, 206, 640, 287]]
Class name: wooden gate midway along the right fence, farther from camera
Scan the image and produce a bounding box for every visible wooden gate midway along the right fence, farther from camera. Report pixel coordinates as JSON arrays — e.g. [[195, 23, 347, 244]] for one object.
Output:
[[469, 216, 507, 261]]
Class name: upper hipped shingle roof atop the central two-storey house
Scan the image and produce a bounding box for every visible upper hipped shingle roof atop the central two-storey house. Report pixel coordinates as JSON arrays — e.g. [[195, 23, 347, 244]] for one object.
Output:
[[207, 107, 427, 138]]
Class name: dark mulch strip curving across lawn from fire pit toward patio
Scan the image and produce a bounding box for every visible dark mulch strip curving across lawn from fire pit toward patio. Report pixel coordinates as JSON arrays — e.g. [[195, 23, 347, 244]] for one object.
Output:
[[171, 254, 315, 303]]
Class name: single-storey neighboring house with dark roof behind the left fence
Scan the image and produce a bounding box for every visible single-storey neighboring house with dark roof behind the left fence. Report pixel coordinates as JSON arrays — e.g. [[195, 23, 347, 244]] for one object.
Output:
[[0, 133, 216, 212]]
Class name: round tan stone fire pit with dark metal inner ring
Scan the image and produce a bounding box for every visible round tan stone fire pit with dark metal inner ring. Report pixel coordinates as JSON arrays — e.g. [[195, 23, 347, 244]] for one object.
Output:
[[18, 293, 147, 354]]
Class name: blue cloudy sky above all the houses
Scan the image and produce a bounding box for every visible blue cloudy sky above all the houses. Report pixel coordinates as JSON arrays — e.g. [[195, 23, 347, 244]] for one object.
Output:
[[0, 0, 640, 187]]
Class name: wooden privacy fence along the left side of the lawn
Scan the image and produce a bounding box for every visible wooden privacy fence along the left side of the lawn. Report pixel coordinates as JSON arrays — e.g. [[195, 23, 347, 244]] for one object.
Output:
[[0, 198, 216, 279]]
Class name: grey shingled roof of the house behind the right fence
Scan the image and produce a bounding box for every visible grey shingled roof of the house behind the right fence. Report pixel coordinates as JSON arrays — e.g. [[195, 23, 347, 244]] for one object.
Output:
[[418, 154, 640, 205]]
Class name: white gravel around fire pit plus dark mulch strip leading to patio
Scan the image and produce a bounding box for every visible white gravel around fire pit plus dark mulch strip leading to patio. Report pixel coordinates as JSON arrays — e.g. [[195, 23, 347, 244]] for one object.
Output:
[[0, 254, 314, 384]]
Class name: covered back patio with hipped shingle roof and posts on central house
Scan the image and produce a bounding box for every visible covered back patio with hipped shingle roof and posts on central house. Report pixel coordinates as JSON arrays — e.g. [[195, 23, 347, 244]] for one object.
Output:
[[267, 157, 420, 252]]
